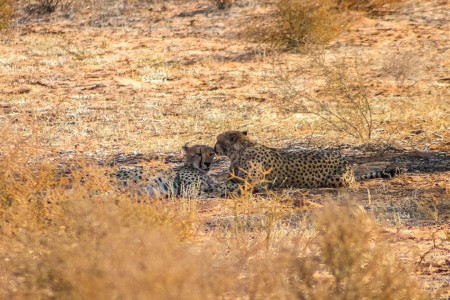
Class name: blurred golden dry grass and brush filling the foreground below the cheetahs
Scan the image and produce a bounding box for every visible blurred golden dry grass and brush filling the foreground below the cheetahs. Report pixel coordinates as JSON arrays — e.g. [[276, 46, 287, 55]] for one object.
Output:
[[0, 140, 428, 299]]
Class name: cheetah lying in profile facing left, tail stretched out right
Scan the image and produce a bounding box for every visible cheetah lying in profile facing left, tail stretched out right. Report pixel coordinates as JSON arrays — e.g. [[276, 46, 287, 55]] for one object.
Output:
[[214, 131, 400, 189]]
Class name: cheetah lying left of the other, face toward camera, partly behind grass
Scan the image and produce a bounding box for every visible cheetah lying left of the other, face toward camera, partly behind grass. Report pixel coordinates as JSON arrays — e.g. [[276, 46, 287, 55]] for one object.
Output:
[[114, 145, 239, 198]]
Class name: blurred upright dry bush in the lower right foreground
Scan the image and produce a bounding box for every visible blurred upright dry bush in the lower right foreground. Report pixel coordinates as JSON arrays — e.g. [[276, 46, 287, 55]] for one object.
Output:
[[315, 204, 428, 299]]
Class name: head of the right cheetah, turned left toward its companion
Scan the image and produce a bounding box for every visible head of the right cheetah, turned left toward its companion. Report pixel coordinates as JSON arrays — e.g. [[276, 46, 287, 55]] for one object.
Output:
[[214, 131, 250, 157]]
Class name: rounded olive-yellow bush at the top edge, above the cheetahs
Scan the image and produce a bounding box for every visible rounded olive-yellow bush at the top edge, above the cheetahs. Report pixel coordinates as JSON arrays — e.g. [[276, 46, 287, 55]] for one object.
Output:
[[251, 0, 347, 50]]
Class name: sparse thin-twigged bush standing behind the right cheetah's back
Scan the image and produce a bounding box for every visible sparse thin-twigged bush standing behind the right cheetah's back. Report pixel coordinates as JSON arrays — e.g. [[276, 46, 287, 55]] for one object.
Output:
[[276, 48, 375, 141]]
